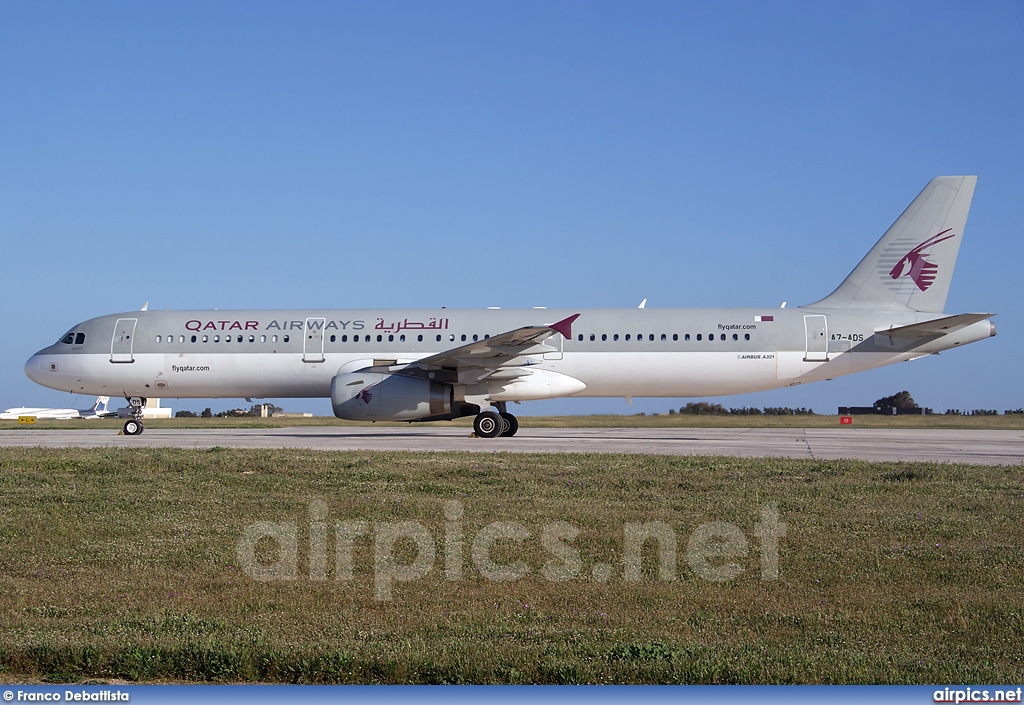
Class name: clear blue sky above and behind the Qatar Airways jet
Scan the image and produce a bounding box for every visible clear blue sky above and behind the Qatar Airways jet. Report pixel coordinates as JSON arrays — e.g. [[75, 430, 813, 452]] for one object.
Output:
[[0, 0, 1024, 414]]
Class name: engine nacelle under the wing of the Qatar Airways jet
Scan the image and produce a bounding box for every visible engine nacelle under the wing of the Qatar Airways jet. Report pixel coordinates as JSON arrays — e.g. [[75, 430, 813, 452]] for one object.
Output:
[[331, 372, 453, 421]]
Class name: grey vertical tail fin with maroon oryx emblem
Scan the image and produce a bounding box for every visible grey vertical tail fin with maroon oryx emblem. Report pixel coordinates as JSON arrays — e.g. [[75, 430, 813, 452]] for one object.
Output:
[[807, 176, 978, 314]]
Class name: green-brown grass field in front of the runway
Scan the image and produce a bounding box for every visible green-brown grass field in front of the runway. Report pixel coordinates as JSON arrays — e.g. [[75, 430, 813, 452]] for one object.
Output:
[[0, 446, 1024, 683]]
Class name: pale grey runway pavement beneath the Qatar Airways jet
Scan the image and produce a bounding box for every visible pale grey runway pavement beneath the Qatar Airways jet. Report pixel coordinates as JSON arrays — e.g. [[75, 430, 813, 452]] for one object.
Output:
[[0, 426, 1024, 465]]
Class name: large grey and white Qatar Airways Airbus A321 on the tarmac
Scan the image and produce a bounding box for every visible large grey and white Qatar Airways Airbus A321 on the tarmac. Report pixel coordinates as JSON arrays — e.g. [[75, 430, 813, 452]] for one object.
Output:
[[25, 176, 995, 439]]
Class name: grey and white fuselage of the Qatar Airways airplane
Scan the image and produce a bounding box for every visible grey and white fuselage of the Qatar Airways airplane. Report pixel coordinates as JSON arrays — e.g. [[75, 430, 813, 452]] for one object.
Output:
[[26, 307, 994, 402]]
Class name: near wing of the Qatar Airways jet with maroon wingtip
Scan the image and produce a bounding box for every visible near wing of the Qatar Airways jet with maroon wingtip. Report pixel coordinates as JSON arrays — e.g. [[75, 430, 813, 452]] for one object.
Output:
[[406, 314, 580, 379]]
